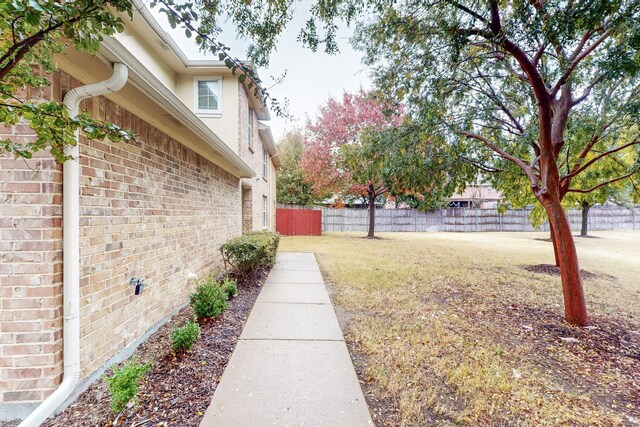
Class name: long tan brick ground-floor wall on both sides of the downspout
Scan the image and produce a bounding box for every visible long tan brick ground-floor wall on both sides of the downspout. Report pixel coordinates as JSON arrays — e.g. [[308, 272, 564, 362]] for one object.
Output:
[[0, 74, 242, 412]]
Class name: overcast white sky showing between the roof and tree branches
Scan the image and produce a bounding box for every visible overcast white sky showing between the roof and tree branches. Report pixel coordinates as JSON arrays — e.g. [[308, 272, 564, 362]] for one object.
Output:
[[152, 2, 371, 141]]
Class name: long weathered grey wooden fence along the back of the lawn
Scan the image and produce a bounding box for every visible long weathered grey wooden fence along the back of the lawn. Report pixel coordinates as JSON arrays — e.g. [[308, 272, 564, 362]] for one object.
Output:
[[278, 206, 640, 232]]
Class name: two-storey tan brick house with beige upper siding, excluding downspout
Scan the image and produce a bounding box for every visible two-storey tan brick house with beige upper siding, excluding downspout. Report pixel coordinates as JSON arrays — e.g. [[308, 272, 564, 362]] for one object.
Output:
[[0, 5, 279, 420]]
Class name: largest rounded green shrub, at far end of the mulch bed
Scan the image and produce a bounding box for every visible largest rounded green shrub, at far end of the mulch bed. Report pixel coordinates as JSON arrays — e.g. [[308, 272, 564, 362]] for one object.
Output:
[[220, 231, 280, 275]]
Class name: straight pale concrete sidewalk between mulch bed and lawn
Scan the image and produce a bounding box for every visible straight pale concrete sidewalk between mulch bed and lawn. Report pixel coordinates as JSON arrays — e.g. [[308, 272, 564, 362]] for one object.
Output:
[[200, 252, 373, 427]]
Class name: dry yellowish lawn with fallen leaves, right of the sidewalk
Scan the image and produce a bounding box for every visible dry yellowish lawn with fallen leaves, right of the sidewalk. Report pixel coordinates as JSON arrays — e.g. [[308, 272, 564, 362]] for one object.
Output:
[[280, 231, 640, 426]]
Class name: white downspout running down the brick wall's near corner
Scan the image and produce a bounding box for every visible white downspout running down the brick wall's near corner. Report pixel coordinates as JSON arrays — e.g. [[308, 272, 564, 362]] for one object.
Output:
[[18, 63, 128, 427]]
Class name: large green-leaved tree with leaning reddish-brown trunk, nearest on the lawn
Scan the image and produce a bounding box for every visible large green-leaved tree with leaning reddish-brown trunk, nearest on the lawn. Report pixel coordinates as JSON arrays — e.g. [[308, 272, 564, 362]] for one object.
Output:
[[356, 1, 640, 325]]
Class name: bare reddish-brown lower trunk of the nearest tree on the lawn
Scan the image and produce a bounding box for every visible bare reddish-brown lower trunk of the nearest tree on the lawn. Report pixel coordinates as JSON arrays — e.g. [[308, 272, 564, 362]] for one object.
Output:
[[544, 200, 589, 326]]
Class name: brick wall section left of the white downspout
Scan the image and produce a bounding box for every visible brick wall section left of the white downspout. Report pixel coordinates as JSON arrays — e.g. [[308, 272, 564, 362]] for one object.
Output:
[[0, 148, 62, 403]]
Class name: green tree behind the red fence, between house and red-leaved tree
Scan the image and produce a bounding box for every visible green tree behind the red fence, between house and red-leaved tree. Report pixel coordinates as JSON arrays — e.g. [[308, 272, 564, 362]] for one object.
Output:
[[276, 129, 313, 205]]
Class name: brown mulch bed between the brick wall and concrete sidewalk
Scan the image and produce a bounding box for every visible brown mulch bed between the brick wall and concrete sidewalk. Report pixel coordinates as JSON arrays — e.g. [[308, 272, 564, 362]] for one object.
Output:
[[37, 270, 268, 427]]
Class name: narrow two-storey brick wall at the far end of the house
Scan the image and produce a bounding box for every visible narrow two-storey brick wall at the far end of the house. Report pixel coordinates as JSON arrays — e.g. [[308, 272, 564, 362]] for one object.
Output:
[[238, 84, 276, 230]]
